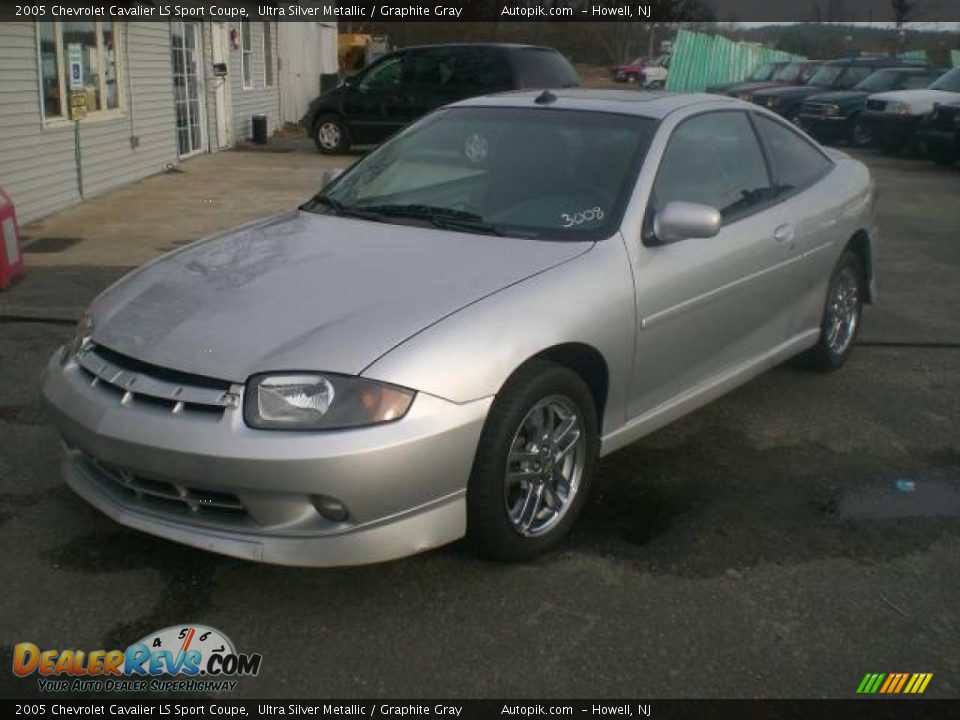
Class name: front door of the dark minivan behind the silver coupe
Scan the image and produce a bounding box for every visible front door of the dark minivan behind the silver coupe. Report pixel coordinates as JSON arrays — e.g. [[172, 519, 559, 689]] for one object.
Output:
[[342, 53, 409, 144]]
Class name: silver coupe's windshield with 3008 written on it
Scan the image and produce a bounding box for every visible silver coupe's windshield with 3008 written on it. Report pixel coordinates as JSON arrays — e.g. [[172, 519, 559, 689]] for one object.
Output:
[[312, 107, 655, 240]]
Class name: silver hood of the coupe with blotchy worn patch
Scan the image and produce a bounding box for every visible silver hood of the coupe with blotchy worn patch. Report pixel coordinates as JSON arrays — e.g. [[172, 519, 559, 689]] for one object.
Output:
[[92, 211, 593, 382]]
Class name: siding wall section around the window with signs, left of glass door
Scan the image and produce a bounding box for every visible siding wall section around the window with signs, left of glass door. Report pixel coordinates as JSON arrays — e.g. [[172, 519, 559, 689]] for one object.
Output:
[[0, 22, 177, 222]]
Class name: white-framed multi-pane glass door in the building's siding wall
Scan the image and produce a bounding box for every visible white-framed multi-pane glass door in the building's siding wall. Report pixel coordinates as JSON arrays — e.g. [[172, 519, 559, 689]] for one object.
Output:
[[170, 21, 205, 158]]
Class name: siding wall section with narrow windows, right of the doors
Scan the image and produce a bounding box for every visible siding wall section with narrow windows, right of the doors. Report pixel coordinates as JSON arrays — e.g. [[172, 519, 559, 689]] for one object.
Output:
[[229, 21, 280, 142]]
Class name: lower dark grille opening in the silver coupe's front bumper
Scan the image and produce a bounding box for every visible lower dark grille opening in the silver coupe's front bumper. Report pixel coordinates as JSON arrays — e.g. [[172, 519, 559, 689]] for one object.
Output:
[[81, 455, 247, 517]]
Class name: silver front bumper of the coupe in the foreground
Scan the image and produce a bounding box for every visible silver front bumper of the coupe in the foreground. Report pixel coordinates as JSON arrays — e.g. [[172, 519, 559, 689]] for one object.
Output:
[[43, 352, 492, 566]]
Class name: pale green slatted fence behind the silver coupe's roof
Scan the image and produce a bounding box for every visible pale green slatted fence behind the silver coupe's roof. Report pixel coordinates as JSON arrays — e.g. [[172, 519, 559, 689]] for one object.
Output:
[[667, 30, 803, 92]]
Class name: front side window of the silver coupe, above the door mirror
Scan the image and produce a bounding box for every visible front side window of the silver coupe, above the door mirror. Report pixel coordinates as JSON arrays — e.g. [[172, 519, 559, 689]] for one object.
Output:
[[651, 111, 772, 228]]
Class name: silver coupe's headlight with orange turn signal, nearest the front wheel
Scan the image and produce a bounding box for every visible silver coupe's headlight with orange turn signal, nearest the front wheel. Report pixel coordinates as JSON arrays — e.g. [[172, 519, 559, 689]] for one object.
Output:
[[243, 373, 416, 430]]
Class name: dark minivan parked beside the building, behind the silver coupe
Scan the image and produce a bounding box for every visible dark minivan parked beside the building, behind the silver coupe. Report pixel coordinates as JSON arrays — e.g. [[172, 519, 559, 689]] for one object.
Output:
[[302, 43, 580, 154]]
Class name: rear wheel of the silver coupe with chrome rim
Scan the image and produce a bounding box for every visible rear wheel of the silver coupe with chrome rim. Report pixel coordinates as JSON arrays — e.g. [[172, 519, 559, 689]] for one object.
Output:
[[803, 250, 866, 372]]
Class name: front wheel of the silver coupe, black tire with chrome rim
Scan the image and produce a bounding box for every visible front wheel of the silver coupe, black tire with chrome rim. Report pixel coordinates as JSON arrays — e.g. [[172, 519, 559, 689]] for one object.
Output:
[[467, 360, 600, 561]]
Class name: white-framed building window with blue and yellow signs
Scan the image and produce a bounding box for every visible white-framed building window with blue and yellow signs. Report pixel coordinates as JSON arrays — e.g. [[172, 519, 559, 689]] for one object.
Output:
[[37, 21, 123, 121]]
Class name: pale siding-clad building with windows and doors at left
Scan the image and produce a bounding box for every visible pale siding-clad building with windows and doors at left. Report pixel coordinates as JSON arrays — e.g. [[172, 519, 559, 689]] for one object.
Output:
[[0, 19, 337, 222]]
